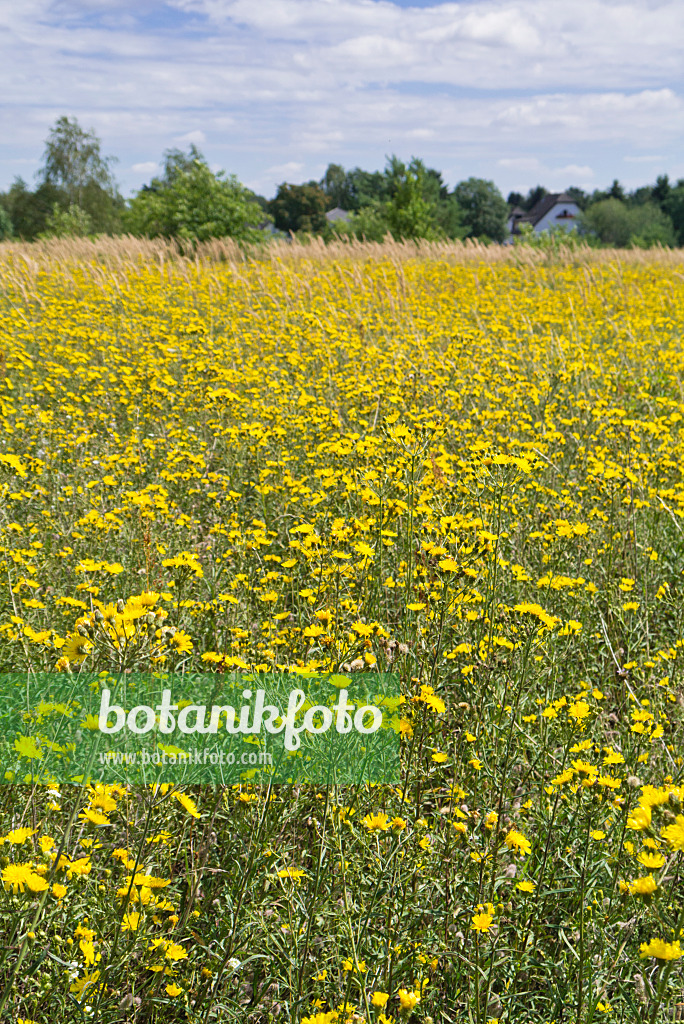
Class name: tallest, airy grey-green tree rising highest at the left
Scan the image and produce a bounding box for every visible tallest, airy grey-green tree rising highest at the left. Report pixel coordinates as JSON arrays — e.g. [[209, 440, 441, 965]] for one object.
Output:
[[38, 117, 124, 231]]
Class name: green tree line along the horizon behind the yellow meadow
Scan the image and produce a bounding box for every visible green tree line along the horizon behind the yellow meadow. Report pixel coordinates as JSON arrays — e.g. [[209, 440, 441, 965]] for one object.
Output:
[[0, 117, 684, 247]]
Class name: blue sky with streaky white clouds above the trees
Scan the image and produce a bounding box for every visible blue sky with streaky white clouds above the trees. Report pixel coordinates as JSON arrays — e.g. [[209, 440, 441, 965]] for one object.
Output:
[[0, 0, 684, 198]]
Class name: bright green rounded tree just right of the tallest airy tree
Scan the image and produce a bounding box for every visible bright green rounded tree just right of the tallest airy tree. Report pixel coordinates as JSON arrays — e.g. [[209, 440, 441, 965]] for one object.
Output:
[[124, 147, 263, 242]]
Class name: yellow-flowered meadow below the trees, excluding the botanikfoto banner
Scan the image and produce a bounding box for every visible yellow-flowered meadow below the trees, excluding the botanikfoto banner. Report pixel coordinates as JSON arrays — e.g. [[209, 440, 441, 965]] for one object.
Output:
[[0, 240, 684, 1024]]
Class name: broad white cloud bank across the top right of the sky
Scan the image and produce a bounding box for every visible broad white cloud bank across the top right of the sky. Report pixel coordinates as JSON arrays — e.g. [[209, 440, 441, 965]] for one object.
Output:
[[174, 0, 684, 89]]
